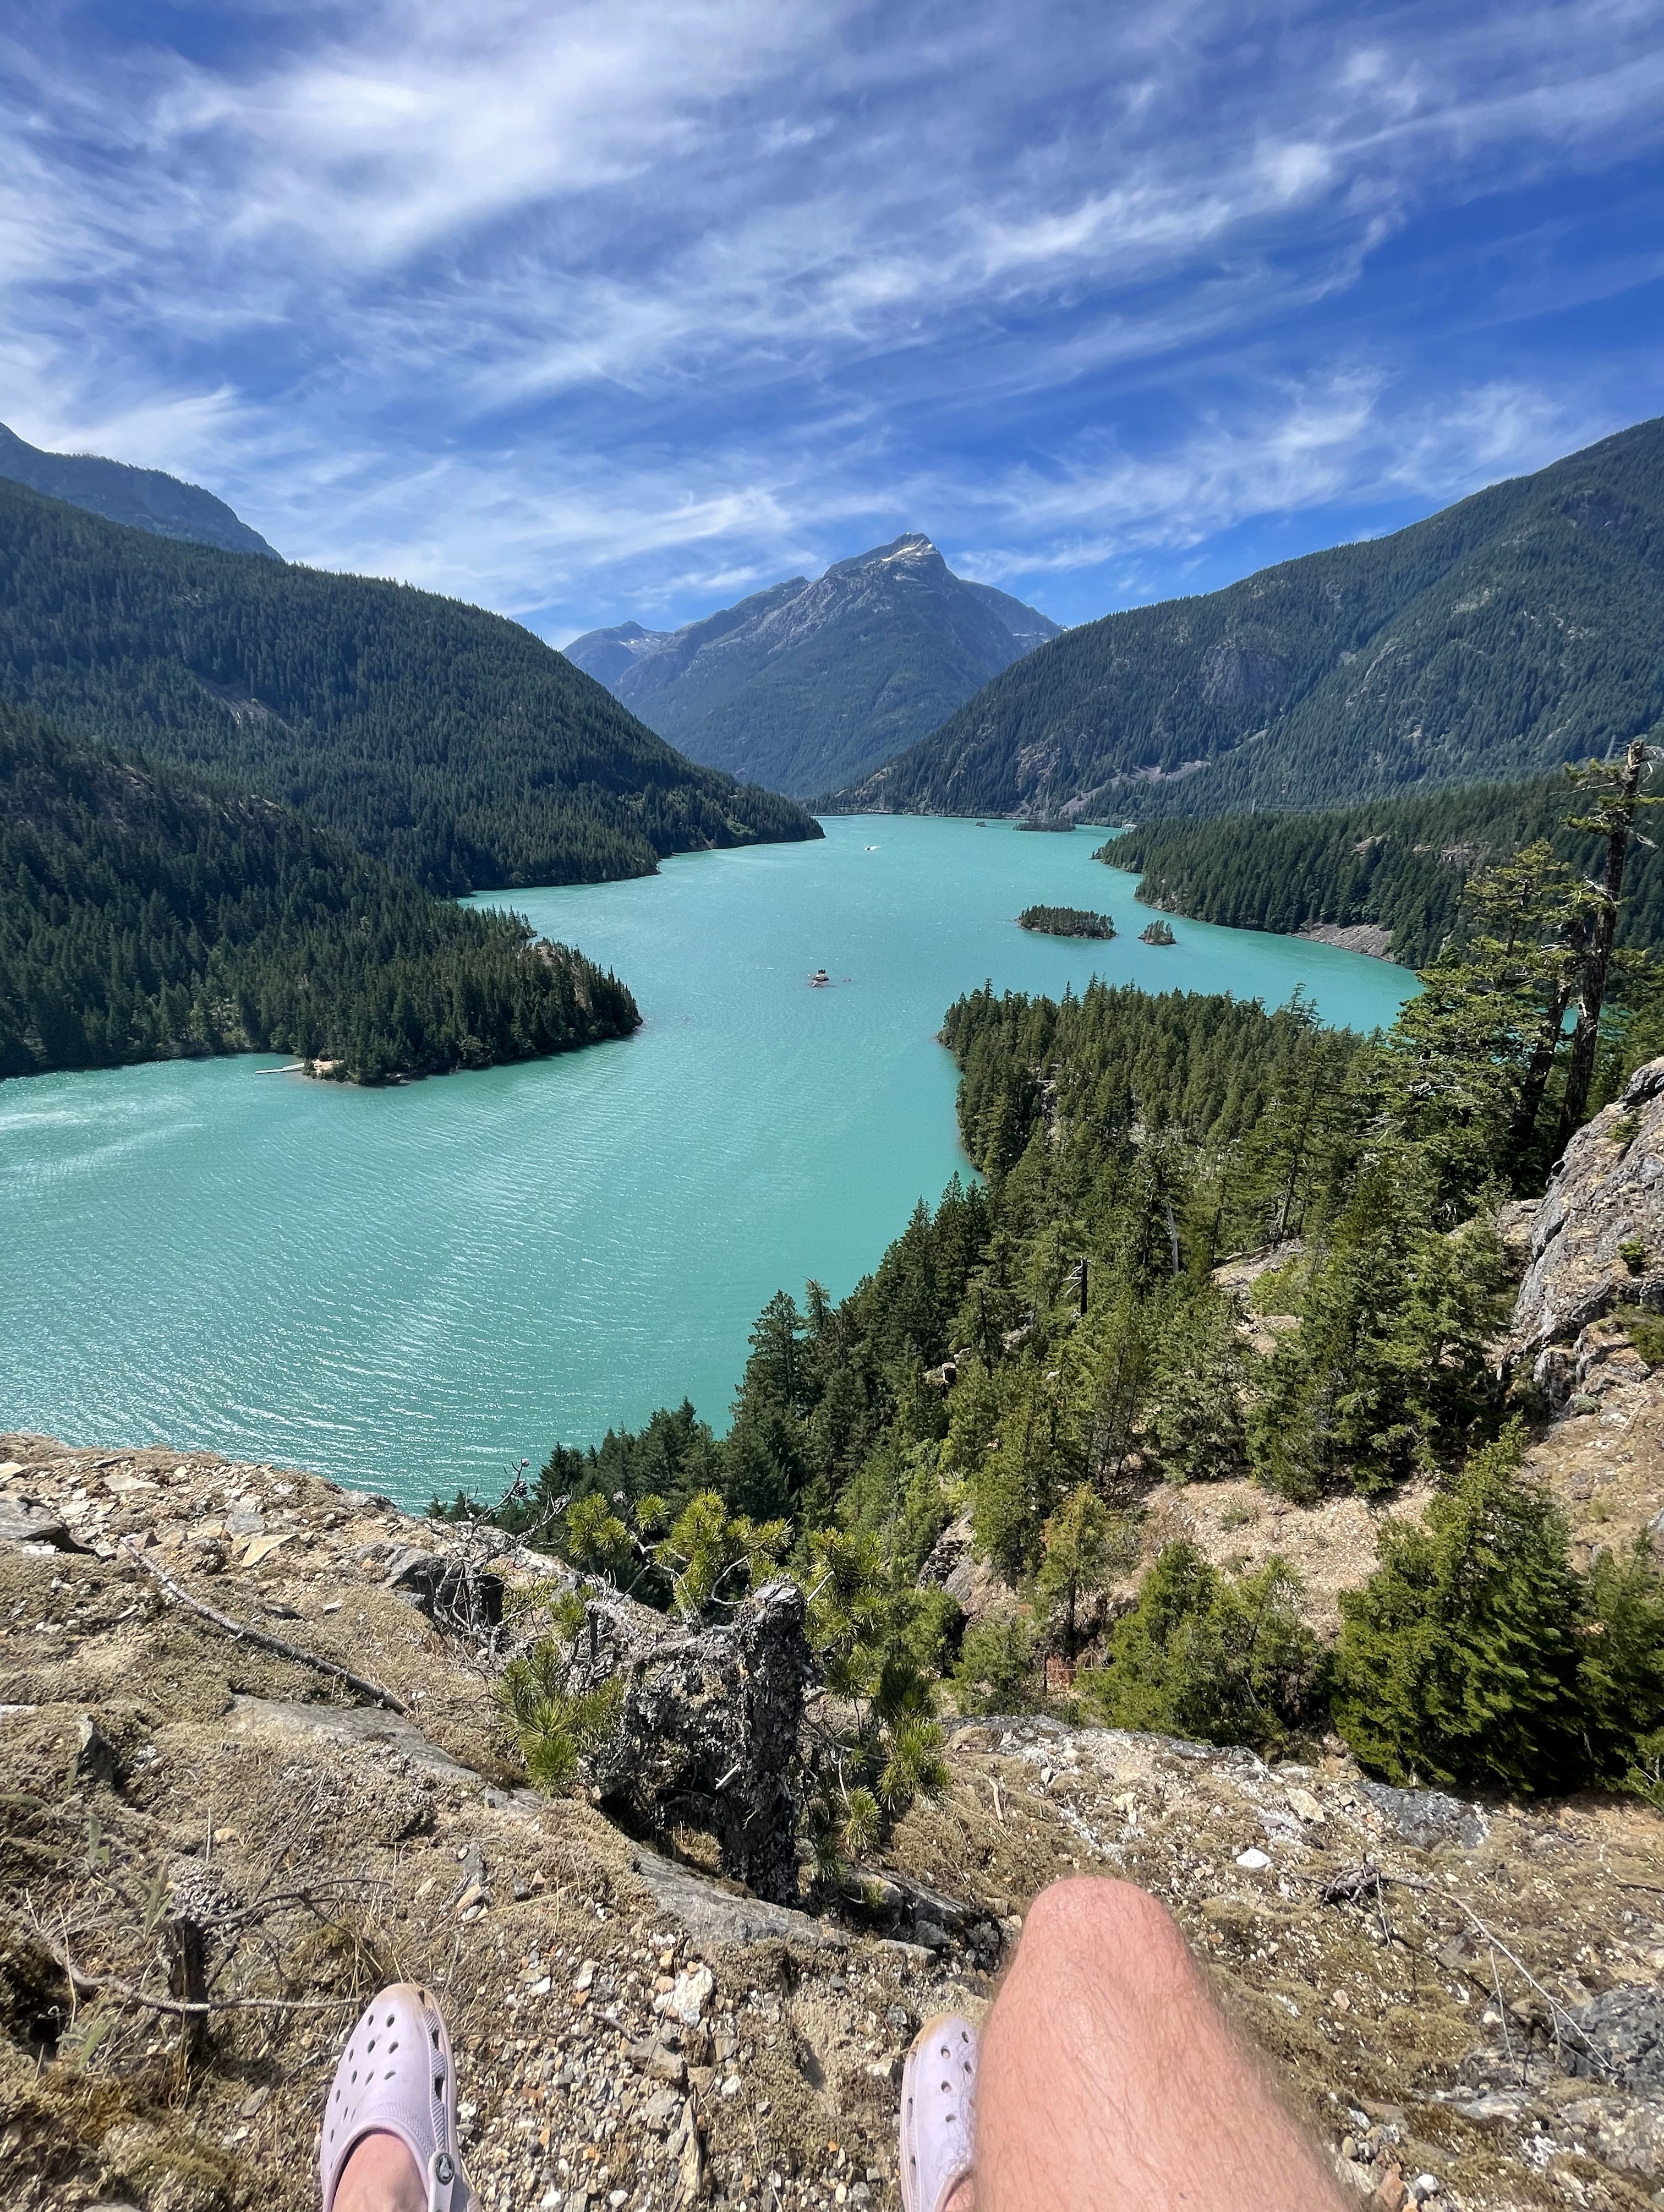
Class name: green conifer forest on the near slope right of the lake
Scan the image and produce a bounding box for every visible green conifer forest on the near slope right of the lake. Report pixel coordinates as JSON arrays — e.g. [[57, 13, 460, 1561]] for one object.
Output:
[[462, 787, 1664, 1822]]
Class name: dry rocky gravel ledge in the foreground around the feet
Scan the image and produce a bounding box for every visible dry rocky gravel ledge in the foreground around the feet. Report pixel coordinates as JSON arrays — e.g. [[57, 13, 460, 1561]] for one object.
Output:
[[0, 1435, 1664, 2212]]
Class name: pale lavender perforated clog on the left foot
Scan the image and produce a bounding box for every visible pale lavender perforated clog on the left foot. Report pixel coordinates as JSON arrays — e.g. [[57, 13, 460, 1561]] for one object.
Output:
[[319, 1982, 476, 2212]]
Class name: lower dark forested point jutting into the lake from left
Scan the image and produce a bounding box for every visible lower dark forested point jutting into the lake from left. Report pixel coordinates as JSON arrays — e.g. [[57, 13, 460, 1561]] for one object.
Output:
[[0, 706, 639, 1082]]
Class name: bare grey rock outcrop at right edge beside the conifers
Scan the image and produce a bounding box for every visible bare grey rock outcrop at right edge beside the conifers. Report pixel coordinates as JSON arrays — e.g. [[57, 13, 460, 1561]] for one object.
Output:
[[1512, 1059, 1664, 1363]]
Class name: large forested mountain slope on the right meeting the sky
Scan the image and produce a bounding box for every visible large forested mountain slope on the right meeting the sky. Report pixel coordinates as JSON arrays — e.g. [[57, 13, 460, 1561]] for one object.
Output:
[[836, 420, 1664, 821]]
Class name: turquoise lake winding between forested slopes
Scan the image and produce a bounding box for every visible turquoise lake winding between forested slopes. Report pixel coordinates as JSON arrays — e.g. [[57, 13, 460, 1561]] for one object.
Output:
[[0, 816, 1412, 1502]]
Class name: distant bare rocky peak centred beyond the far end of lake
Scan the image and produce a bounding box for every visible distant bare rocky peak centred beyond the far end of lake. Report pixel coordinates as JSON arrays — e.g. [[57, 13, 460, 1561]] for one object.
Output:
[[566, 533, 1060, 799]]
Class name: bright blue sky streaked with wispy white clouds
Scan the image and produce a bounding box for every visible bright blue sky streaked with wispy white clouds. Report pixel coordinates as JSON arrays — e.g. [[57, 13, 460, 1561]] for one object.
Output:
[[0, 0, 1664, 642]]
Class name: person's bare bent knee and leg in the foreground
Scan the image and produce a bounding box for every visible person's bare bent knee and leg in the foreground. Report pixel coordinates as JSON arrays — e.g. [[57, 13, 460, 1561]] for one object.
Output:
[[973, 1878, 1341, 2212]]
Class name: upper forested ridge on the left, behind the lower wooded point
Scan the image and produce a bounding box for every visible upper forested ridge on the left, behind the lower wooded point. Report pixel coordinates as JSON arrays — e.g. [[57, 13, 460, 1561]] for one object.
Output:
[[0, 482, 821, 892]]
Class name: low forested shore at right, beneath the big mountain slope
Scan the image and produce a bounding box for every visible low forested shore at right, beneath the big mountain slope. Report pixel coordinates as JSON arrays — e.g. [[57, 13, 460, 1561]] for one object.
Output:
[[1100, 777, 1664, 966]]
